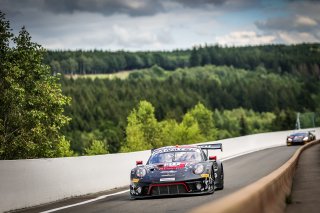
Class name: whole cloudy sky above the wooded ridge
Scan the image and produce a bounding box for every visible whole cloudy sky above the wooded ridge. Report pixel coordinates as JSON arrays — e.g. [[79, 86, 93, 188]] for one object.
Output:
[[0, 0, 320, 51]]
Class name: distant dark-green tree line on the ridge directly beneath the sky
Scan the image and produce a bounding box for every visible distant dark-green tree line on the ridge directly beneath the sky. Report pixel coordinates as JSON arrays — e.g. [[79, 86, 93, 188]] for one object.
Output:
[[44, 43, 320, 78]]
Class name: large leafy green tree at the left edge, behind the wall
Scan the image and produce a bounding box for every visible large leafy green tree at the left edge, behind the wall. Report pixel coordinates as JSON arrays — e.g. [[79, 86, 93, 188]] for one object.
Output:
[[0, 12, 70, 159]]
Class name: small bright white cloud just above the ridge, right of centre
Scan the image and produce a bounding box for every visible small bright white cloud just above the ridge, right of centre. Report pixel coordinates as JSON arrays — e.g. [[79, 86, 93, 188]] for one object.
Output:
[[216, 31, 276, 46]]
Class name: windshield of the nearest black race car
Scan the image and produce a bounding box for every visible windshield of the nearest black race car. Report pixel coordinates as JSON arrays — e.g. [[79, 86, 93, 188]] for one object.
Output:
[[148, 150, 202, 164]]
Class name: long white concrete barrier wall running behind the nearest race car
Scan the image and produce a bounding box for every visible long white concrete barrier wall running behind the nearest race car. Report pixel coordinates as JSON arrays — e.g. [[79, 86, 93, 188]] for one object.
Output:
[[0, 128, 320, 212]]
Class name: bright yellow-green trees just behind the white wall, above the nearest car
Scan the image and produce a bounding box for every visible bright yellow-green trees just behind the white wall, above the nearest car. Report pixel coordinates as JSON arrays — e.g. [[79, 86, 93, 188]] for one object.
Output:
[[120, 101, 275, 152]]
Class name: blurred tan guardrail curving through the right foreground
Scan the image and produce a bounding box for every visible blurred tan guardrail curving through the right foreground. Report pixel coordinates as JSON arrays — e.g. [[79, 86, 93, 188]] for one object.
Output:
[[191, 140, 320, 213]]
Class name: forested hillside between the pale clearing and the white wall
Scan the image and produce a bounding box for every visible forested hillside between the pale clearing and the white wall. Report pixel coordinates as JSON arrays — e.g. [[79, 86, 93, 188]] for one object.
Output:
[[61, 55, 320, 155]]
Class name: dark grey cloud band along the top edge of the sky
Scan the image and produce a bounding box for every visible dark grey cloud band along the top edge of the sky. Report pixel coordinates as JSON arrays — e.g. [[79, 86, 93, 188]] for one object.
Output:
[[0, 0, 257, 16]]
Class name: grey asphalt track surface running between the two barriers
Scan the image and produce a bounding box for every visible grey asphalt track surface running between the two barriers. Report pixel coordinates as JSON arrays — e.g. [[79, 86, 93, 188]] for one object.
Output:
[[19, 146, 300, 213]]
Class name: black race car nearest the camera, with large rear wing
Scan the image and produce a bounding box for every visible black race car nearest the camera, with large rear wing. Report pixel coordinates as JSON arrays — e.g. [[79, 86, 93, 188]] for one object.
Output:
[[130, 143, 224, 198]]
